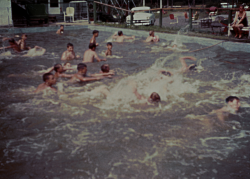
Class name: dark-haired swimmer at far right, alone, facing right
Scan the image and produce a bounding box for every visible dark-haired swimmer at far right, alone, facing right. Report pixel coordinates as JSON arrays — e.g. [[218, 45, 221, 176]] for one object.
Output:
[[212, 96, 240, 121]]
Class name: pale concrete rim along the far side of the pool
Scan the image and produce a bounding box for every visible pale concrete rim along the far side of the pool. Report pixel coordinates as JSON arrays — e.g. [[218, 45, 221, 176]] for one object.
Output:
[[0, 22, 250, 52]]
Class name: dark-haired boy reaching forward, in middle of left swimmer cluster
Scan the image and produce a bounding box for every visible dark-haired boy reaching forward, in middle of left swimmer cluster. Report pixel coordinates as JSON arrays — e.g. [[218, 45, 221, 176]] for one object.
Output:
[[70, 63, 103, 82]]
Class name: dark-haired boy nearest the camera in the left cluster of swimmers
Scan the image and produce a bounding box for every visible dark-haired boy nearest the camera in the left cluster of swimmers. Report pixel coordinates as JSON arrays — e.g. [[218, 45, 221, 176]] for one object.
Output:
[[34, 73, 57, 93]]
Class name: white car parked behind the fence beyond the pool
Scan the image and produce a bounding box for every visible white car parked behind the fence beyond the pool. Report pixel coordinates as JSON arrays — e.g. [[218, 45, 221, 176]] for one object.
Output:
[[126, 6, 155, 25]]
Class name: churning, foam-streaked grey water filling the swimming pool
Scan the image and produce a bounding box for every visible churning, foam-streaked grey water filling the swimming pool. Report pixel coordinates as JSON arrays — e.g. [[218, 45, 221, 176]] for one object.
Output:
[[0, 29, 250, 179]]
